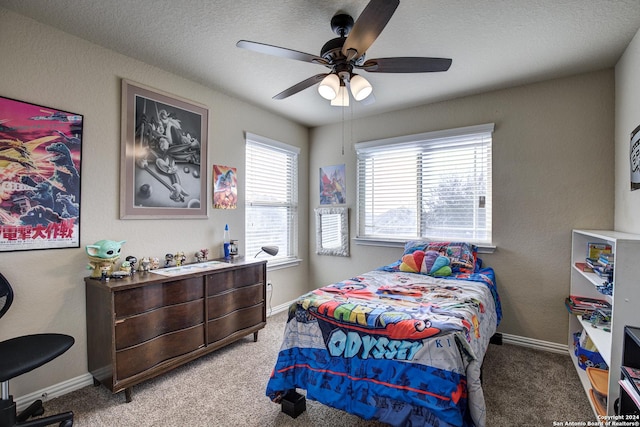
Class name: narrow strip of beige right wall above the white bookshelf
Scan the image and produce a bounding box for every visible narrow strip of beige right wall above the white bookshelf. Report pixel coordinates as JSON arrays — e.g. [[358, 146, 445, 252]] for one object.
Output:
[[615, 27, 640, 233]]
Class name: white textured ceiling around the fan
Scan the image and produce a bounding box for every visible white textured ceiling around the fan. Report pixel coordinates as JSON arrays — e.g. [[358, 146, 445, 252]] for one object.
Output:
[[0, 0, 640, 126]]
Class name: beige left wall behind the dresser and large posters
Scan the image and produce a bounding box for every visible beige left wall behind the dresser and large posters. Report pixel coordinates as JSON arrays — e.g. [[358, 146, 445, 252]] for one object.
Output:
[[0, 8, 308, 396]]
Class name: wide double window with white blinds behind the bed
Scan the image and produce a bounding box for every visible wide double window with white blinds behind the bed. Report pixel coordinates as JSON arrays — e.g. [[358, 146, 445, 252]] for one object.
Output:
[[355, 124, 493, 243]]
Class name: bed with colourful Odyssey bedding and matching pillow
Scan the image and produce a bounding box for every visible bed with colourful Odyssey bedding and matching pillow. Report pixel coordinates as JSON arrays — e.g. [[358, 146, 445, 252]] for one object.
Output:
[[266, 241, 501, 427]]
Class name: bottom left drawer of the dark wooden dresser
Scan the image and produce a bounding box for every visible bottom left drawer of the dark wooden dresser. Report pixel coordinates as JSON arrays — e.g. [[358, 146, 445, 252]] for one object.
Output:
[[116, 325, 204, 380]]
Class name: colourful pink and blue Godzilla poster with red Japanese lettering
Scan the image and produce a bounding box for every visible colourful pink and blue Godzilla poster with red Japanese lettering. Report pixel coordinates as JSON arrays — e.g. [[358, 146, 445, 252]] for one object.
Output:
[[0, 97, 83, 251]]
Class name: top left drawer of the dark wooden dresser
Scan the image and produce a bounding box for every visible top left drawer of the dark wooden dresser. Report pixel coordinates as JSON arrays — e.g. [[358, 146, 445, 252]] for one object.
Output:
[[113, 277, 204, 318]]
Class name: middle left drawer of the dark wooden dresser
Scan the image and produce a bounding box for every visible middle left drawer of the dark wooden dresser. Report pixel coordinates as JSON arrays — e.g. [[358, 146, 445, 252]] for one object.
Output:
[[116, 298, 204, 350]]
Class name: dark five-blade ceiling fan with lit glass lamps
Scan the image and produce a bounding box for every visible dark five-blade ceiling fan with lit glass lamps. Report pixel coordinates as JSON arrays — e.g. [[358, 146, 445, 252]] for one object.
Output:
[[236, 0, 451, 106]]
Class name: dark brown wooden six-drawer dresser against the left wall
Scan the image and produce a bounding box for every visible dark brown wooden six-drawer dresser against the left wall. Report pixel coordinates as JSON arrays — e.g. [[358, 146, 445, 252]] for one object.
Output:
[[85, 259, 267, 402]]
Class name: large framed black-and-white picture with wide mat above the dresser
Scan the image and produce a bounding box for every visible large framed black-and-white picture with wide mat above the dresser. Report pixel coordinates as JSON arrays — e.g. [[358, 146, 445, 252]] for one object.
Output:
[[120, 80, 208, 219]]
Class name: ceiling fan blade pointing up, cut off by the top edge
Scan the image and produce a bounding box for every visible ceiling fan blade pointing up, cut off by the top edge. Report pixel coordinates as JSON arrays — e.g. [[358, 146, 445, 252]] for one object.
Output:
[[342, 0, 400, 61]]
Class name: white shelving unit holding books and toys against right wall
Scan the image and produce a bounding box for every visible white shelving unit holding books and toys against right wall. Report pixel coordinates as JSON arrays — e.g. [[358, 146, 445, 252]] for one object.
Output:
[[568, 230, 640, 415]]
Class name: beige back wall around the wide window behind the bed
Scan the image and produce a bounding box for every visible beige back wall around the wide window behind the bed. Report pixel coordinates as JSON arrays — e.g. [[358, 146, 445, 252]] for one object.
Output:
[[309, 69, 614, 344]]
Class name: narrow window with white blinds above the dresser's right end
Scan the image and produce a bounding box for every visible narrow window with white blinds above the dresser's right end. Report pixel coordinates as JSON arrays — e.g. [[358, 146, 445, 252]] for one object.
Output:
[[245, 133, 300, 264]]
